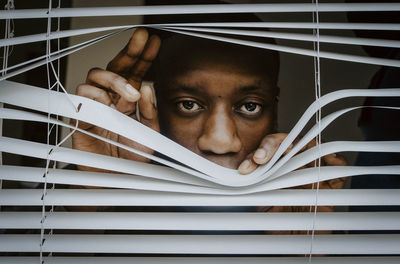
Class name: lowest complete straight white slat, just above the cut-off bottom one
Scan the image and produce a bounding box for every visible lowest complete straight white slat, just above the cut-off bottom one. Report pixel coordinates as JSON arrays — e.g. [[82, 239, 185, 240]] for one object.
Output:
[[0, 234, 400, 255]]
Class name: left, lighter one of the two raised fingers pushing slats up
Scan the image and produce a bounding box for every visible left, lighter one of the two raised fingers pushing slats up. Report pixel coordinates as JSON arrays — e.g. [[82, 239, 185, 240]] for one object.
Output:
[[107, 28, 149, 73]]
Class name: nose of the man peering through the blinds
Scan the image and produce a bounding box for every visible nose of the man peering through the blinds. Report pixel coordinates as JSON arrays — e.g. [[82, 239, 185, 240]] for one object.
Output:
[[197, 107, 242, 154]]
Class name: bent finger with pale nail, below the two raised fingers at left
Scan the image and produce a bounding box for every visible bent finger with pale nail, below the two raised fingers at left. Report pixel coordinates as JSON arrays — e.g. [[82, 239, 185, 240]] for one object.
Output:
[[86, 68, 140, 102]]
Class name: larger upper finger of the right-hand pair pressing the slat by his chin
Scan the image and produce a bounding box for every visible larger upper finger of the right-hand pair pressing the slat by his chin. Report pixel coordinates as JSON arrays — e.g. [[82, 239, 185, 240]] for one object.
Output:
[[253, 133, 287, 165]]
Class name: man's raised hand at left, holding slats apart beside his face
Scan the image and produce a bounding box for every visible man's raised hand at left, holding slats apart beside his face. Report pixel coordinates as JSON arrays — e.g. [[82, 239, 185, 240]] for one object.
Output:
[[71, 28, 161, 171]]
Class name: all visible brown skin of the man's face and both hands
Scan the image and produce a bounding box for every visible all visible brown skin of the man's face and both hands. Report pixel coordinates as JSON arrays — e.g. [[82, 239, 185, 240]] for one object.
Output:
[[73, 29, 345, 174]]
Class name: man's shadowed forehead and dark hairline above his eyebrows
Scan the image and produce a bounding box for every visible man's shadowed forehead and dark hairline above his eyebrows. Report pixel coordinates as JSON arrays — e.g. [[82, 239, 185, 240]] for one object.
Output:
[[158, 35, 278, 83]]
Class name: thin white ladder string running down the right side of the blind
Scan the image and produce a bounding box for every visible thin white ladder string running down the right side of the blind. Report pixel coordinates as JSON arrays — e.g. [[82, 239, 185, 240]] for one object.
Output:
[[308, 0, 322, 263]]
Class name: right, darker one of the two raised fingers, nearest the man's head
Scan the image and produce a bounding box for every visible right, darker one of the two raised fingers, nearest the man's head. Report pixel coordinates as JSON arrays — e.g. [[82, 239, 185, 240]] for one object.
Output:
[[129, 35, 161, 84]]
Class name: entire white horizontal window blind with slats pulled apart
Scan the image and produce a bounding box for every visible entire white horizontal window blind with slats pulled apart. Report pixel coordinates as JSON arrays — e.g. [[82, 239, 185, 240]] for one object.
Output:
[[0, 1, 400, 263]]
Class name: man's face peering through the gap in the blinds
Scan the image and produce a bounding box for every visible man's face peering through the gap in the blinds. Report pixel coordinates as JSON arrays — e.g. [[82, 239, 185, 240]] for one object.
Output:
[[157, 41, 276, 169]]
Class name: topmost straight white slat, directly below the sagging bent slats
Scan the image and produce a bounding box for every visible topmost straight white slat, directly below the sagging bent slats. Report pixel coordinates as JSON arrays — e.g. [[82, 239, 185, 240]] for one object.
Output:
[[0, 189, 400, 206]]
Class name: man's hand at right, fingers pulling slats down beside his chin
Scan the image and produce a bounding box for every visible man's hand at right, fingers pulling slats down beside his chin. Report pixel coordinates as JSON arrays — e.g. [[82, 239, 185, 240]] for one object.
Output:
[[238, 133, 347, 174]]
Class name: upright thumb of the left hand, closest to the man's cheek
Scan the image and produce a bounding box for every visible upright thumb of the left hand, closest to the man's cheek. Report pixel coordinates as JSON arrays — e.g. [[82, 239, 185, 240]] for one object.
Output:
[[139, 84, 160, 132]]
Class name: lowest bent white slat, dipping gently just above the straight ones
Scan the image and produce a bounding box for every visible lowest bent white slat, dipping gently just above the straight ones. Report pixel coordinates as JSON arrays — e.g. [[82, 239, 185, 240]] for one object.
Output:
[[0, 165, 400, 195]]
